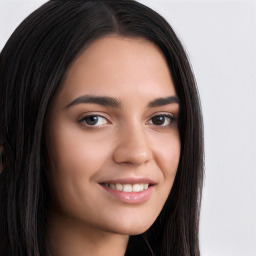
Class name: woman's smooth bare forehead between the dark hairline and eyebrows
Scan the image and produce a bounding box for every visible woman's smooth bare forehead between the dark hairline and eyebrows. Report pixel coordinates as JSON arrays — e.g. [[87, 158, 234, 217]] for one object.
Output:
[[57, 35, 175, 105]]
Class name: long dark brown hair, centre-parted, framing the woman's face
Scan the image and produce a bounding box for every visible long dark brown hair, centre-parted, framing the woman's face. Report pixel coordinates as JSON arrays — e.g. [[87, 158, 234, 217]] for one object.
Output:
[[0, 0, 203, 256]]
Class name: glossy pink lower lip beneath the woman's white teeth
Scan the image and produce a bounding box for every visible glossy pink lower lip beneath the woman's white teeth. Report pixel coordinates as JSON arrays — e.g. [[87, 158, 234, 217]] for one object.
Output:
[[101, 185, 154, 204]]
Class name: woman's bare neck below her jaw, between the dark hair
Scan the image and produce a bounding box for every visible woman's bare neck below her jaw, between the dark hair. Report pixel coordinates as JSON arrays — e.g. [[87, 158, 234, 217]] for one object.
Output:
[[46, 211, 129, 256]]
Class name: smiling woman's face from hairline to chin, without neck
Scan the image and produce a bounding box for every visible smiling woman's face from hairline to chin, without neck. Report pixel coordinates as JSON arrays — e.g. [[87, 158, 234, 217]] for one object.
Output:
[[46, 36, 180, 235]]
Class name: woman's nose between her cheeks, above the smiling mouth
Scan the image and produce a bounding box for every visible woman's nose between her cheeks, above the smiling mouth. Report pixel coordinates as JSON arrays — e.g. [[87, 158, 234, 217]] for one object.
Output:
[[113, 125, 153, 165]]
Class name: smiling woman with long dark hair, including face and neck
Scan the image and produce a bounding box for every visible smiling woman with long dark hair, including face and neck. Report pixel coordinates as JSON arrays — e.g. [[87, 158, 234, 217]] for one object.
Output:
[[0, 0, 203, 256]]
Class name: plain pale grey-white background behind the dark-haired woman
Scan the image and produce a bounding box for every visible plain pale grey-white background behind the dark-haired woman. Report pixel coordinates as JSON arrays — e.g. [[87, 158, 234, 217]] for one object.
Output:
[[0, 0, 256, 256]]
